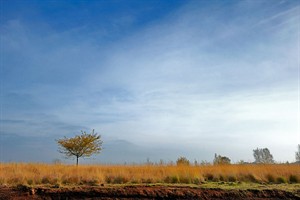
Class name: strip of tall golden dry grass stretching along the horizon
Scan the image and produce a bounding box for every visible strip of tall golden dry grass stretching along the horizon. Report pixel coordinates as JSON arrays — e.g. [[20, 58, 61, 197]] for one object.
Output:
[[0, 163, 300, 186]]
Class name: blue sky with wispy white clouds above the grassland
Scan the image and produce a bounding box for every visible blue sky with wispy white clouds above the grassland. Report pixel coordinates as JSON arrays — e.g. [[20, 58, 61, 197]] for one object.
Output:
[[0, 0, 300, 163]]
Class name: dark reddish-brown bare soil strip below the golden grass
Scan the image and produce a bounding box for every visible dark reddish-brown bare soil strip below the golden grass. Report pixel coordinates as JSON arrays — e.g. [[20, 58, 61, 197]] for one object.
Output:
[[0, 185, 300, 200]]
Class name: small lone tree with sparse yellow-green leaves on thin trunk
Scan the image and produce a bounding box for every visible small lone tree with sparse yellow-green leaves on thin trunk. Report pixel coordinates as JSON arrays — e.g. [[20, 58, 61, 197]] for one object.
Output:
[[57, 129, 102, 165]]
